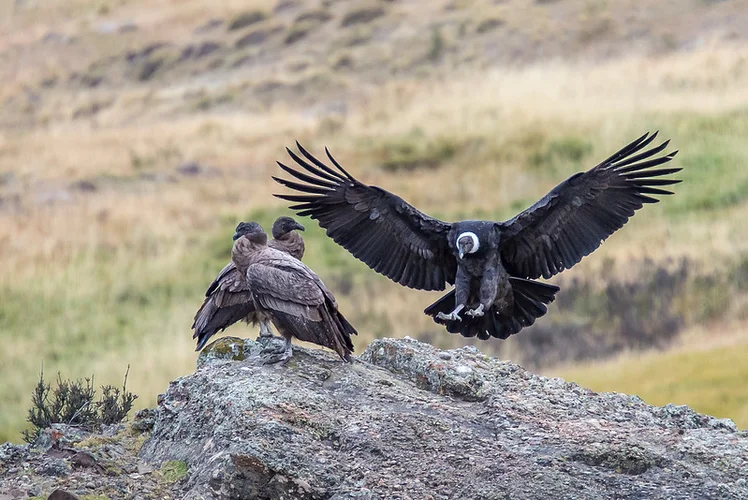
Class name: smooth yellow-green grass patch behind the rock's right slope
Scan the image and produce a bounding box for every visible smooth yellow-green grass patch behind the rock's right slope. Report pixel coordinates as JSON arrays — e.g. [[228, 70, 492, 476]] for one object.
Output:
[[547, 342, 748, 429]]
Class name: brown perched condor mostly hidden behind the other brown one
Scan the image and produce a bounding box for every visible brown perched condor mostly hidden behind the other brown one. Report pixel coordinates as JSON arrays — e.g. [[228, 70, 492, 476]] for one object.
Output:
[[192, 216, 304, 351]]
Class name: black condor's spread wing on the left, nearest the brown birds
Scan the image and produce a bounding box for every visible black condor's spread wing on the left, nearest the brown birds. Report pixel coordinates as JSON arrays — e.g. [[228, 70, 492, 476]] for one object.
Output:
[[273, 142, 457, 290]]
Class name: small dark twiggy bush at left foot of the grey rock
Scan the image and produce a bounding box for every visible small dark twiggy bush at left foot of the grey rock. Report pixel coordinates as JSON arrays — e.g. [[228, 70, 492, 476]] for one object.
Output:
[[23, 365, 138, 443]]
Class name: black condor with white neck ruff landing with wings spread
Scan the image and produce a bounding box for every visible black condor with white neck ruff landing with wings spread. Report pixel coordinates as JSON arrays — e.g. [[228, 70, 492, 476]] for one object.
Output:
[[274, 133, 680, 339]]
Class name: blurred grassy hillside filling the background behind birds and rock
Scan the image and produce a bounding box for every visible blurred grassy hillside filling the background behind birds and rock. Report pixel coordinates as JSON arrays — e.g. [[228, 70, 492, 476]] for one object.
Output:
[[0, 0, 748, 441]]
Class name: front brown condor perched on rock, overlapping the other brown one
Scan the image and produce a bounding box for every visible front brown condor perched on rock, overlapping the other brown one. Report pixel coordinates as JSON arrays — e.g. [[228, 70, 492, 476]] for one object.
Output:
[[231, 222, 357, 361]]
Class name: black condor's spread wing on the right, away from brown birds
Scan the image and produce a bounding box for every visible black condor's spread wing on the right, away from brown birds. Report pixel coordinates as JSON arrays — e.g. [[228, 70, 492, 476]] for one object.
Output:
[[498, 132, 681, 279]]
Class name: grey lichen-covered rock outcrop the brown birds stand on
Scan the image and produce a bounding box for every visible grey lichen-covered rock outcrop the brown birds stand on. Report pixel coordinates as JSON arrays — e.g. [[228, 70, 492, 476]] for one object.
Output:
[[0, 337, 748, 499]]
